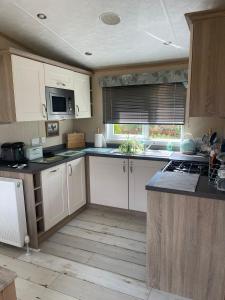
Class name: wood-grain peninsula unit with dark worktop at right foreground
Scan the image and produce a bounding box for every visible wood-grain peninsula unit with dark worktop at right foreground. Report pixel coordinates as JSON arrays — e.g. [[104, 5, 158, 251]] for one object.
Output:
[[146, 172, 225, 300]]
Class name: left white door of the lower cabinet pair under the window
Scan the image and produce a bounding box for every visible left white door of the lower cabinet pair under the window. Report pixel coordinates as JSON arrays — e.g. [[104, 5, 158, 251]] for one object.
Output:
[[89, 156, 128, 209]]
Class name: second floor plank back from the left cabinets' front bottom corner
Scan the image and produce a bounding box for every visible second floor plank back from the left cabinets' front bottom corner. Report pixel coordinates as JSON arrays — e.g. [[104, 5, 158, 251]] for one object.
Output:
[[49, 233, 146, 266]]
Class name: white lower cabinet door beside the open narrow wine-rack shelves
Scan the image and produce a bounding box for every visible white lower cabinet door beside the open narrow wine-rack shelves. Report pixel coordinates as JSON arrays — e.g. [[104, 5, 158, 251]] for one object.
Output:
[[41, 164, 69, 231]]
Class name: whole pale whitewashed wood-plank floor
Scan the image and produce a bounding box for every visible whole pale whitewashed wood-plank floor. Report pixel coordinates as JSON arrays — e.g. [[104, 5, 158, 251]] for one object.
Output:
[[0, 207, 191, 300]]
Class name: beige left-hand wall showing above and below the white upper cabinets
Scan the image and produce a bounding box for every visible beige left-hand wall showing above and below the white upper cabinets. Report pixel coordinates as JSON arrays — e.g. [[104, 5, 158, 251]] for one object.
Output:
[[0, 34, 74, 147]]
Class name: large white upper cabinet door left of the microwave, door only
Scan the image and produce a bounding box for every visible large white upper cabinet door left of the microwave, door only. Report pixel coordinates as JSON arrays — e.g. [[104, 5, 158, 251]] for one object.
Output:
[[11, 55, 47, 121]]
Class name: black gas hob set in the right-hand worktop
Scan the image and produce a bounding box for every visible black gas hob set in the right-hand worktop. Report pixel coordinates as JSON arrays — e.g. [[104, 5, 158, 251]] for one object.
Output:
[[164, 160, 209, 176]]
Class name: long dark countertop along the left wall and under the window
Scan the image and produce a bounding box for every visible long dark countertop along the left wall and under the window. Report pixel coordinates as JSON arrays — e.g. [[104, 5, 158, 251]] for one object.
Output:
[[0, 148, 207, 174]]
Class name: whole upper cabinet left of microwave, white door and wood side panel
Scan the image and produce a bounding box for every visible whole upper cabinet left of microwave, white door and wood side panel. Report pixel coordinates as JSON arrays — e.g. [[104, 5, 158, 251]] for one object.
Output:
[[0, 54, 47, 122]]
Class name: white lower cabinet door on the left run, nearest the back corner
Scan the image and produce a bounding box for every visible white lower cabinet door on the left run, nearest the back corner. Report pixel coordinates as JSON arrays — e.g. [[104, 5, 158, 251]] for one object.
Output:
[[67, 157, 86, 215]]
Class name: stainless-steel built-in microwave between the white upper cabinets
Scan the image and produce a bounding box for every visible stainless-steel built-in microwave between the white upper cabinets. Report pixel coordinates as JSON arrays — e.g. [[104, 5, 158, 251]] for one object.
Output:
[[45, 87, 75, 120]]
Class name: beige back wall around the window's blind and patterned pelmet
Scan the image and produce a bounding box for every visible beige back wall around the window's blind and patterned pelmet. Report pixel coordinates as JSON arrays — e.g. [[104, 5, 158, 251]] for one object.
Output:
[[75, 60, 225, 142]]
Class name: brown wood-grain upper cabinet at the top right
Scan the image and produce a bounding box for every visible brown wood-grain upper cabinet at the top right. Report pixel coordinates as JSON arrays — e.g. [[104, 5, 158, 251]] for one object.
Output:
[[186, 10, 225, 117]]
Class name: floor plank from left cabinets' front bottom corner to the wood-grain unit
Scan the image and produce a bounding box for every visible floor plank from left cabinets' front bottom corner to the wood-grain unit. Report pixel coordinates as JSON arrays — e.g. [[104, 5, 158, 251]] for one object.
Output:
[[41, 241, 146, 281]]
